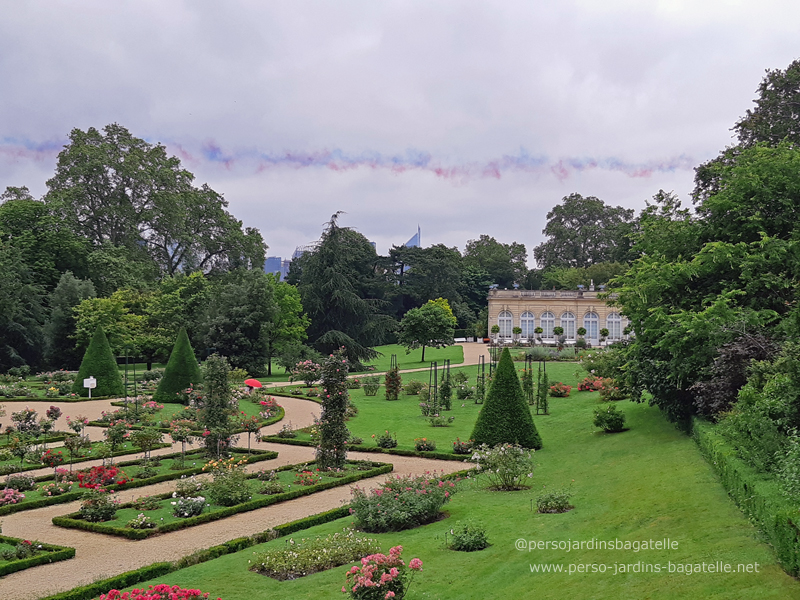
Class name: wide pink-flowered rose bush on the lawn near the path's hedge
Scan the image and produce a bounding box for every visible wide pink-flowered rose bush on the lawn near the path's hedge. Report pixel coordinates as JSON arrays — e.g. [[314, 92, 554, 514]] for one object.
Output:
[[350, 473, 456, 532]]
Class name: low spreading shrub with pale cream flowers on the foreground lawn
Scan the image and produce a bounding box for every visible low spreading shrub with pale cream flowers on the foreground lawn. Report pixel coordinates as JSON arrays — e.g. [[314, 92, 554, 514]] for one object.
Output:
[[248, 529, 380, 581]]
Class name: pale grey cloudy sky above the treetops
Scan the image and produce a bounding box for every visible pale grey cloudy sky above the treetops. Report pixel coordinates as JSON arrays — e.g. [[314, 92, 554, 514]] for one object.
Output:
[[0, 0, 800, 266]]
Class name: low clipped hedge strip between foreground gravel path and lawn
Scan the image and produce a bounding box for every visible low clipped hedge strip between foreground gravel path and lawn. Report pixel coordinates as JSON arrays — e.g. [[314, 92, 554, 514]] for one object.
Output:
[[41, 506, 350, 600]]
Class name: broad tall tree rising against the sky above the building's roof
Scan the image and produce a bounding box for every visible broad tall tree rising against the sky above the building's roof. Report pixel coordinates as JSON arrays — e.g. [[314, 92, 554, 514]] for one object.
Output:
[[533, 194, 634, 269]]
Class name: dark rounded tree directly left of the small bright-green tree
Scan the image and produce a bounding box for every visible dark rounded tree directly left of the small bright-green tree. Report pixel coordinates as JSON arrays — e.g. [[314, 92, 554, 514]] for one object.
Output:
[[204, 269, 278, 376]]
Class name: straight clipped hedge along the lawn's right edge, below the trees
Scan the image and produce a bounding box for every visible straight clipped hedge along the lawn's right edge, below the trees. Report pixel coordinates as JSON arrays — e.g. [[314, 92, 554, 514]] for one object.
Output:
[[692, 419, 800, 577]]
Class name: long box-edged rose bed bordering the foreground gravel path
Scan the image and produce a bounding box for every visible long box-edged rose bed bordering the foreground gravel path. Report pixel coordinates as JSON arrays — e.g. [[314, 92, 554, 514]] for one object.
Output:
[[53, 461, 392, 540]]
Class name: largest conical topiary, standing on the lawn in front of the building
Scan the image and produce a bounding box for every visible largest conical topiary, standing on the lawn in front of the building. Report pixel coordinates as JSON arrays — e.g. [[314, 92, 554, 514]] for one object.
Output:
[[472, 348, 542, 450]]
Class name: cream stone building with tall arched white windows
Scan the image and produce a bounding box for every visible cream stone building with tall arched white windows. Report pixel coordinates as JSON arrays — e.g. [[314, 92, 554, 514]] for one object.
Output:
[[489, 289, 628, 345]]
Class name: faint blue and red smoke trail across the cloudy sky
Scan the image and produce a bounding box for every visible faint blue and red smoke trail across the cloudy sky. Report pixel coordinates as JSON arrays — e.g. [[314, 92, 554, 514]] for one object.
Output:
[[0, 138, 696, 182]]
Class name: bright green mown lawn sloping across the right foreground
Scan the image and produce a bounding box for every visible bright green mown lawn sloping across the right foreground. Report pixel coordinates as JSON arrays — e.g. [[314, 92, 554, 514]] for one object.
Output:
[[128, 365, 800, 600]]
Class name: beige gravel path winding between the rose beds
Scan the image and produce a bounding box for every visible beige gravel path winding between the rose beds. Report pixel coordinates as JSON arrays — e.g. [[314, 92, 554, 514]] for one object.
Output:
[[0, 376, 476, 600]]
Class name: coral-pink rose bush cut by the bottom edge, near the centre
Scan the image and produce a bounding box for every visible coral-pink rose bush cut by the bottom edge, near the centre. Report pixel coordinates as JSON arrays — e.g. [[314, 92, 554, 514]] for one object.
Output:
[[342, 546, 422, 600]]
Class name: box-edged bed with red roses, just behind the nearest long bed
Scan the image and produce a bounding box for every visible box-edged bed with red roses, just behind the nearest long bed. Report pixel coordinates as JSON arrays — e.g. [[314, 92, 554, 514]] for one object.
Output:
[[0, 448, 278, 515]]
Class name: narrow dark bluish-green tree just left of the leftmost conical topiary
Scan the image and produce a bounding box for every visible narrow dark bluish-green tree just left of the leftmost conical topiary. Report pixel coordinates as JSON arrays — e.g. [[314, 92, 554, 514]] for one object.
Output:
[[44, 271, 95, 371]]
